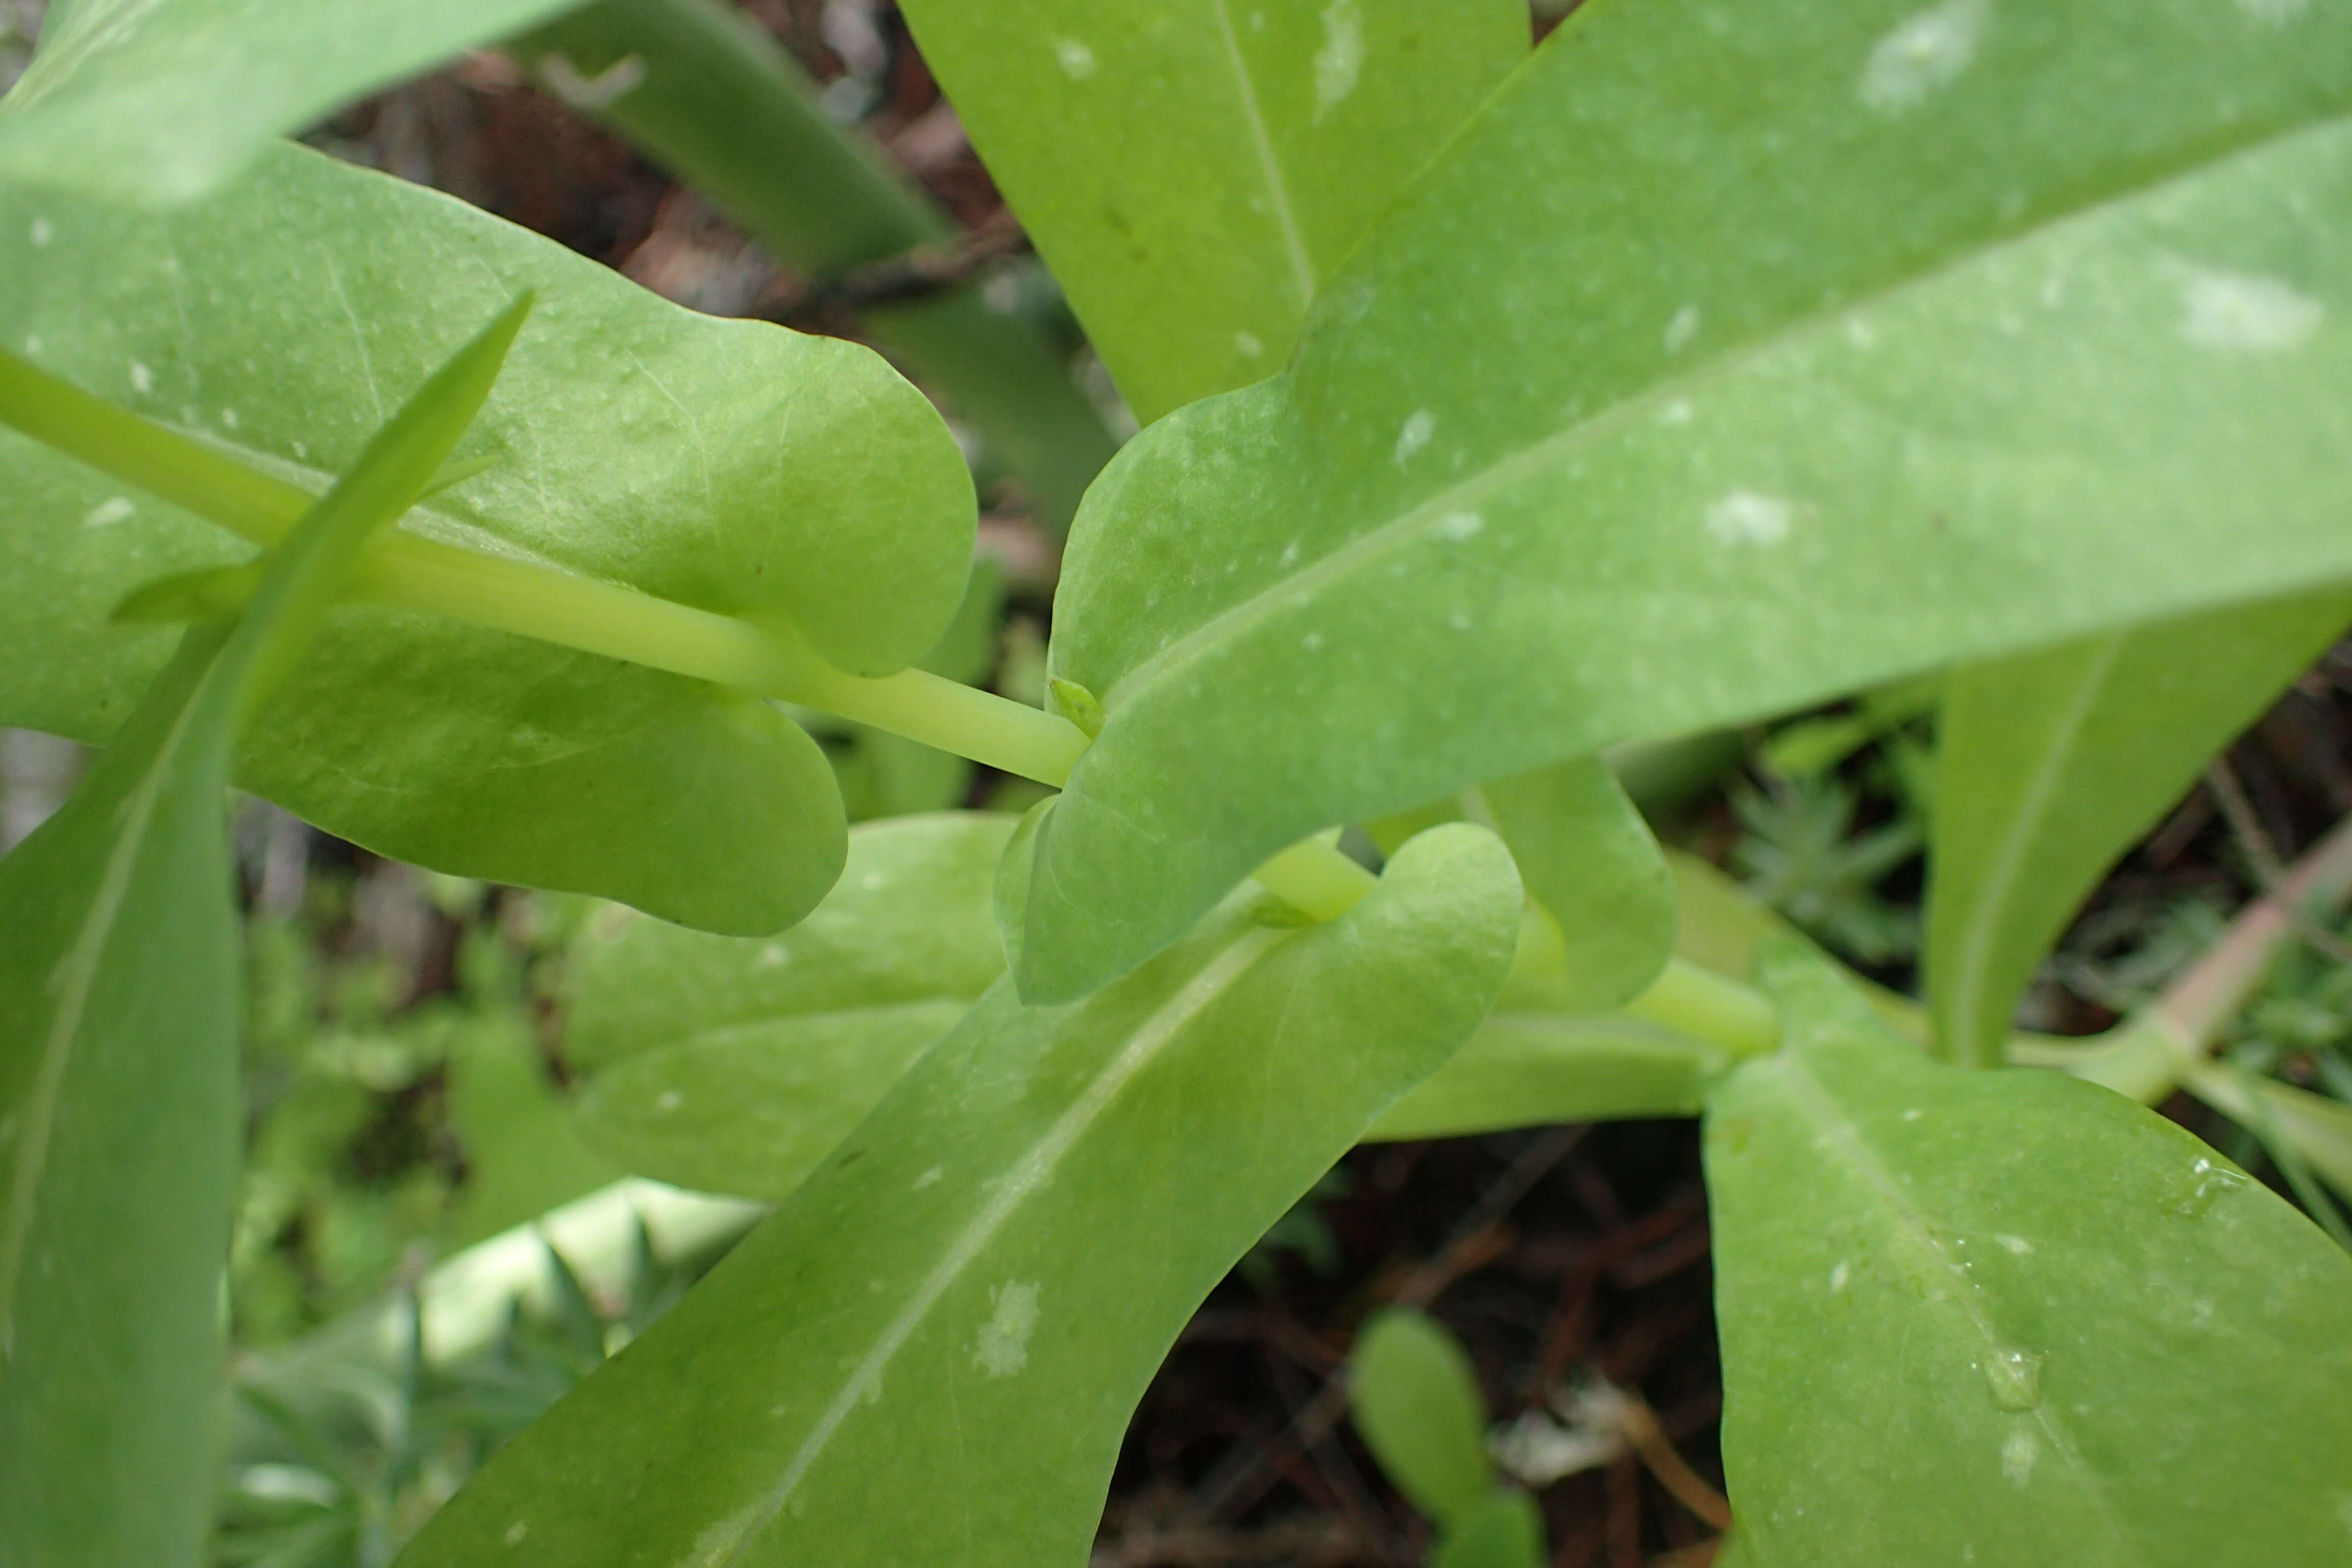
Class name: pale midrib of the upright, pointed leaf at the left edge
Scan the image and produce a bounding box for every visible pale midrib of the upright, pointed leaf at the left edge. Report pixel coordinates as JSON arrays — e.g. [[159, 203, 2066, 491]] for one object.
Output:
[[0, 649, 226, 1352]]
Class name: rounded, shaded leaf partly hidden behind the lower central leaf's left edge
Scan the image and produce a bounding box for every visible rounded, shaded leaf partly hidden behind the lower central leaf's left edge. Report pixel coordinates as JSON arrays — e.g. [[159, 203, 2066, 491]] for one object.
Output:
[[567, 811, 1014, 1202]]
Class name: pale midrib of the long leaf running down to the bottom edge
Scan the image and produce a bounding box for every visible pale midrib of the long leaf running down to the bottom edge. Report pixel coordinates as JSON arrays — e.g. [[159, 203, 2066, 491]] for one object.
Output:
[[689, 926, 1296, 1568]]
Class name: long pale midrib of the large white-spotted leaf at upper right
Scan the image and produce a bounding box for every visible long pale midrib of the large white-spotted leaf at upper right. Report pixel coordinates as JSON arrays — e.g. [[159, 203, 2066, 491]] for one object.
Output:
[[1080, 113, 2352, 719]]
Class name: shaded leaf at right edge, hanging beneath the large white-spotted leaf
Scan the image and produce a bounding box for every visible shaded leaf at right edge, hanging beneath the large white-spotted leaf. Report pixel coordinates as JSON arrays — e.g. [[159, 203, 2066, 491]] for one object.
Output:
[[1926, 590, 2352, 1063]]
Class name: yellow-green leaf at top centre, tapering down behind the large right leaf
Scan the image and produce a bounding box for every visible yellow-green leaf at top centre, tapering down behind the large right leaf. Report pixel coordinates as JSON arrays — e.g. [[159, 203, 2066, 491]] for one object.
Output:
[[903, 0, 1527, 423]]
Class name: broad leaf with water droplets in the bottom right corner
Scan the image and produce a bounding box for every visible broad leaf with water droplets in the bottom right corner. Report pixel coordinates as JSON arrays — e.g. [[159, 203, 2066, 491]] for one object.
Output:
[[1707, 952, 2352, 1568]]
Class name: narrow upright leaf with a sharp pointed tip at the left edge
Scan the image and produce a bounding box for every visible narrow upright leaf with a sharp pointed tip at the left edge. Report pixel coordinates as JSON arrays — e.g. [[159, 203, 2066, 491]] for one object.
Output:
[[0, 310, 522, 1568]]
